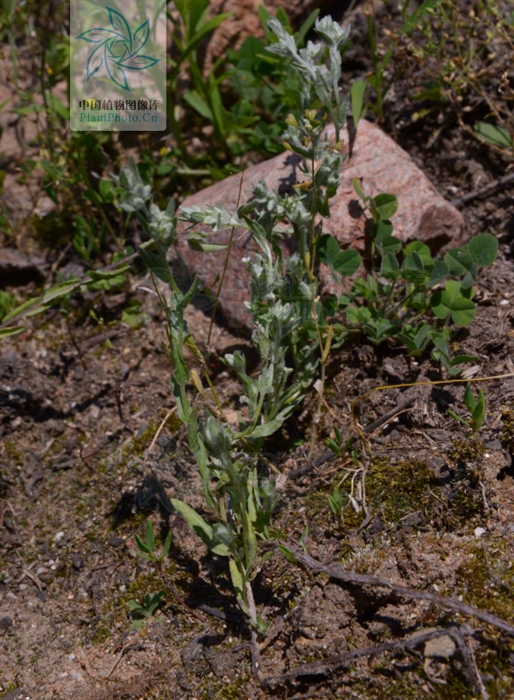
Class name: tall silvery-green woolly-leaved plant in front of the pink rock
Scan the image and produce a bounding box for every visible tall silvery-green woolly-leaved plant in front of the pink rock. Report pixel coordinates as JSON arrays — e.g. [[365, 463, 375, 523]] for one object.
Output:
[[110, 13, 349, 634]]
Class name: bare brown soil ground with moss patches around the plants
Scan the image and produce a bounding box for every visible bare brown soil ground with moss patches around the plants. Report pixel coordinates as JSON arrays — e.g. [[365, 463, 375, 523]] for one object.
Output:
[[0, 1, 514, 700]]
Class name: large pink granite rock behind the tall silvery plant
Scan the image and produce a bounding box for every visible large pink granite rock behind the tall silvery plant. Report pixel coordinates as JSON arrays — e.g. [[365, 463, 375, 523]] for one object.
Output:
[[175, 120, 465, 334]]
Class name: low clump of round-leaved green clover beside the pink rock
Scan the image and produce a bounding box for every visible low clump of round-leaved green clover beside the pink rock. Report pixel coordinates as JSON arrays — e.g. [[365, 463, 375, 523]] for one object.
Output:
[[317, 179, 498, 374]]
